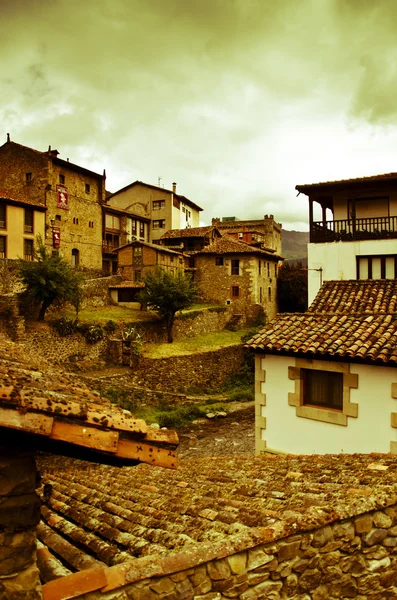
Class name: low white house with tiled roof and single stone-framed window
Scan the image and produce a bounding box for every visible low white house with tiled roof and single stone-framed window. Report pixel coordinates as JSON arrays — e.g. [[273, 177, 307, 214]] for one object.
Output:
[[247, 279, 397, 454]]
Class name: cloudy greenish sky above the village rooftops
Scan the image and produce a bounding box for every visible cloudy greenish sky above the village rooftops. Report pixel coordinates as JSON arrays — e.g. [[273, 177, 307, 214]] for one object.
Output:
[[0, 0, 397, 230]]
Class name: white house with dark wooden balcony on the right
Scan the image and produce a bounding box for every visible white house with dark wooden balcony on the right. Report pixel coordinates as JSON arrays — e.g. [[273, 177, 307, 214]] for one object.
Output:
[[296, 173, 397, 304]]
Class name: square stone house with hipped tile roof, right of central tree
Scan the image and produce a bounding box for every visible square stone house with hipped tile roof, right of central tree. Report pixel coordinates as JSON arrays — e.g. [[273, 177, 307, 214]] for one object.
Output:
[[191, 235, 282, 322]]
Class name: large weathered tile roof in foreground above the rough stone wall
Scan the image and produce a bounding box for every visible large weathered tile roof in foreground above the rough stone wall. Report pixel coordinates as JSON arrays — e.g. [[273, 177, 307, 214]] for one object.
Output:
[[38, 454, 397, 598]]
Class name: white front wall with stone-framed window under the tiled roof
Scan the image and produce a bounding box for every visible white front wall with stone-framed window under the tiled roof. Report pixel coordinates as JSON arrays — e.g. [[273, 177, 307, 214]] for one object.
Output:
[[256, 353, 397, 454]]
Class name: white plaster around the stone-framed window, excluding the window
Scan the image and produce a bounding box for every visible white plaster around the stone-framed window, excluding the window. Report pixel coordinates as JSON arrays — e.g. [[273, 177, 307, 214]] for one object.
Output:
[[256, 355, 397, 454]]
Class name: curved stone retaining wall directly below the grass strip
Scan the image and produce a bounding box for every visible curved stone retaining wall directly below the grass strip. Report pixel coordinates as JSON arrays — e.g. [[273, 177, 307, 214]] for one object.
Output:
[[131, 344, 245, 392]]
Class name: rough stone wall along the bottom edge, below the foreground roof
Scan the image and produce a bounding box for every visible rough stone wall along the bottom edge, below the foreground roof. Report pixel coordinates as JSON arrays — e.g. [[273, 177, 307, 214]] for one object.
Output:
[[54, 502, 397, 600]]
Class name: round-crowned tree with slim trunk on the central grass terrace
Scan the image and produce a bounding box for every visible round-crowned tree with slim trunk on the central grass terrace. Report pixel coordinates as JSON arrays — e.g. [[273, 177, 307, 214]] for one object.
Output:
[[139, 267, 197, 344]]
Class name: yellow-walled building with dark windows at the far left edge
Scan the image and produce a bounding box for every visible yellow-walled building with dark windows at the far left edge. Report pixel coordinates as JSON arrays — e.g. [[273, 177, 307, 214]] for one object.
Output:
[[0, 190, 47, 260]]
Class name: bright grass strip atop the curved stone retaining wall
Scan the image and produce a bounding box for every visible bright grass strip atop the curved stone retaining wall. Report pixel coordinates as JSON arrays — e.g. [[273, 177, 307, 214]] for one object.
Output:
[[143, 329, 251, 358]]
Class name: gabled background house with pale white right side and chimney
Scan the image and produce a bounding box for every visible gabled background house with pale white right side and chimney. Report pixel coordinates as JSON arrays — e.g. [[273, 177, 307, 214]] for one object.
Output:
[[107, 181, 203, 242]]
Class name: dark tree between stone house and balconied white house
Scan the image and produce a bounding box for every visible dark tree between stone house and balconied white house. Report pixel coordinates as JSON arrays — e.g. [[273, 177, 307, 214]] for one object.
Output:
[[277, 262, 307, 312]]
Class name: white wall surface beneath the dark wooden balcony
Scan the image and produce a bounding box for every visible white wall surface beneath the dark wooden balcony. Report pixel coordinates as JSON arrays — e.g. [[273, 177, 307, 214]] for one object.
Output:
[[307, 239, 397, 305]]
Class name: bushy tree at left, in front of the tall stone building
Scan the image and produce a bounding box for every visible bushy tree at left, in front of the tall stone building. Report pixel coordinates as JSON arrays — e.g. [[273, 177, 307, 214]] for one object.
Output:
[[18, 236, 82, 321]]
